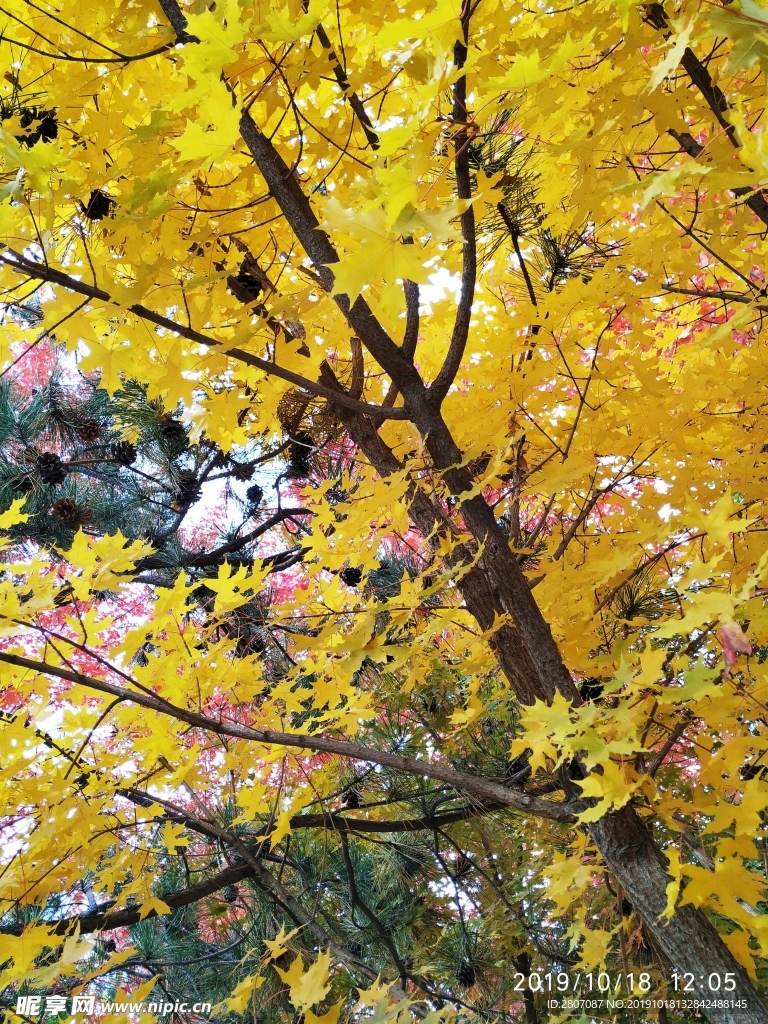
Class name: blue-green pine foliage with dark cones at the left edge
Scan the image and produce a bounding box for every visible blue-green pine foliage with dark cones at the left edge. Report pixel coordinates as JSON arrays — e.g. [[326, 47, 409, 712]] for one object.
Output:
[[0, 367, 198, 551]]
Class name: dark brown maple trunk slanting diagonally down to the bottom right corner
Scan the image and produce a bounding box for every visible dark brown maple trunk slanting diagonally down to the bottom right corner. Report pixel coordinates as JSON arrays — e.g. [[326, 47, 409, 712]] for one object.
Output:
[[240, 105, 768, 1024]]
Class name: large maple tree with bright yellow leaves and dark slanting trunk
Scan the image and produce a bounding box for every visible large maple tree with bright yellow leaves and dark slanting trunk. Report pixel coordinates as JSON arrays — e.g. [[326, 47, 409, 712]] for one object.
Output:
[[0, 0, 768, 1022]]
